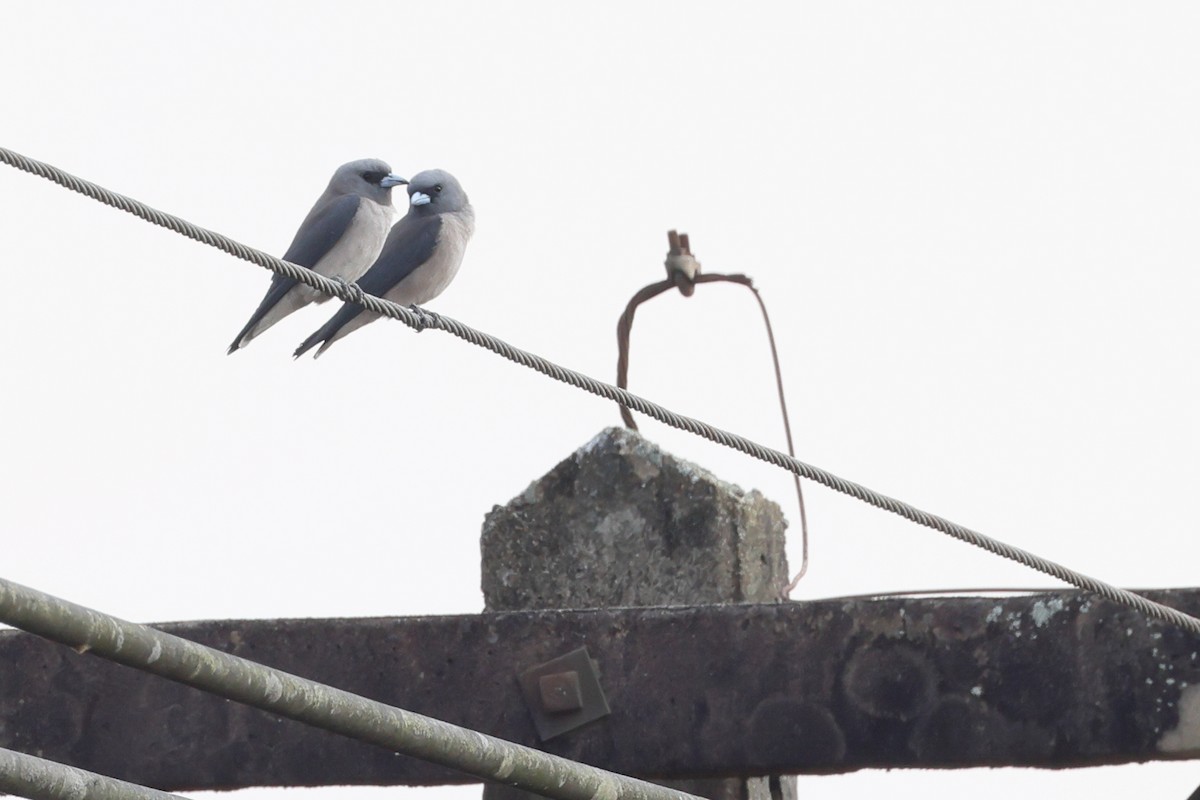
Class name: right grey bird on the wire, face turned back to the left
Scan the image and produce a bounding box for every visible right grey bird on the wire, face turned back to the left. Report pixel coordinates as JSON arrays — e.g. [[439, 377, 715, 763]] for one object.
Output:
[[295, 169, 475, 359]]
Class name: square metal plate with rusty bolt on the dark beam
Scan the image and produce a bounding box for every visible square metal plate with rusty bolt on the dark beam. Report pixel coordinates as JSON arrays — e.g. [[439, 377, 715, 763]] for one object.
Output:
[[517, 648, 612, 741]]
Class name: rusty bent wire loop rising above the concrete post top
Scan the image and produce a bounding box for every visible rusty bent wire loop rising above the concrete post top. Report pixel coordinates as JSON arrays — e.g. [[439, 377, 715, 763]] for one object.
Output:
[[617, 230, 809, 599]]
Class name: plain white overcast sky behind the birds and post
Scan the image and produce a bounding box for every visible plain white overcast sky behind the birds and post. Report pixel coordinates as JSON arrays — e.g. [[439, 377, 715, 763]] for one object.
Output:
[[0, 0, 1200, 800]]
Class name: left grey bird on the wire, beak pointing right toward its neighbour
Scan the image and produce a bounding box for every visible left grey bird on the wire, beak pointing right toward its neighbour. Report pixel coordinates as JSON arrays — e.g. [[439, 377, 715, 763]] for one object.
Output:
[[229, 158, 408, 353]]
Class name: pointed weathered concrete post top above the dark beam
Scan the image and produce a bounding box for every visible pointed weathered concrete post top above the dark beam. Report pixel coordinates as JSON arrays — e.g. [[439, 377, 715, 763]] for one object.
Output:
[[481, 428, 787, 610]]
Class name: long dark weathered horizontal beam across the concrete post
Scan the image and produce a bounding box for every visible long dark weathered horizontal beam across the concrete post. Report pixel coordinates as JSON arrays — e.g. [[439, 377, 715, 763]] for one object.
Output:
[[0, 590, 1200, 790]]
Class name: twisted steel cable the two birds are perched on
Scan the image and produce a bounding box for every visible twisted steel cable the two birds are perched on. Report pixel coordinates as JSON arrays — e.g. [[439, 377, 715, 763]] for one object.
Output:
[[0, 148, 1200, 633]]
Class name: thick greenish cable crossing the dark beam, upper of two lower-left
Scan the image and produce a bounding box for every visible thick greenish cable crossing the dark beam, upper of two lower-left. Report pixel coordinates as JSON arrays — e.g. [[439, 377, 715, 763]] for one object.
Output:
[[0, 578, 701, 800]]
